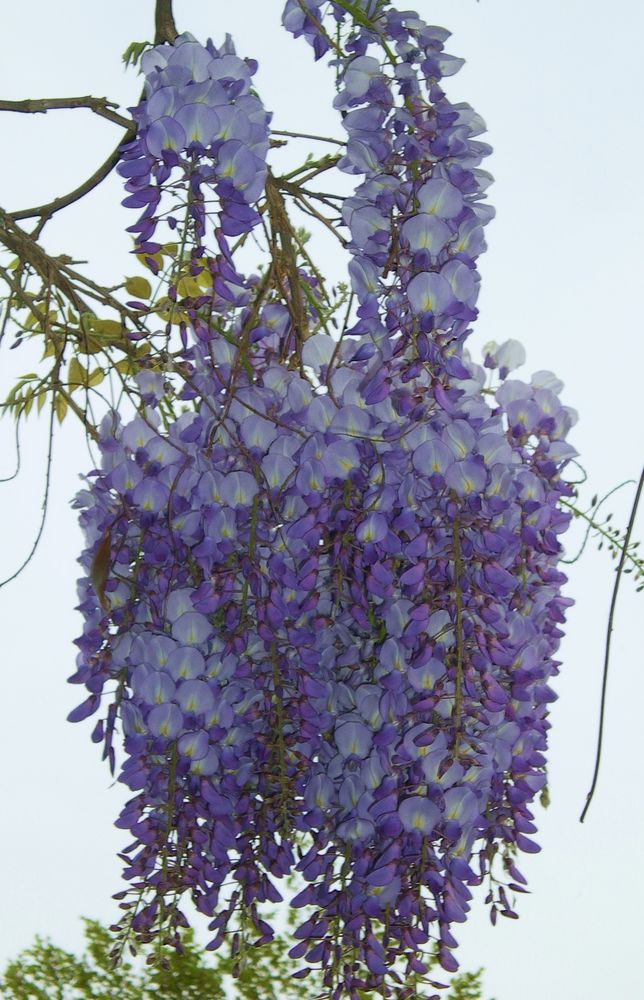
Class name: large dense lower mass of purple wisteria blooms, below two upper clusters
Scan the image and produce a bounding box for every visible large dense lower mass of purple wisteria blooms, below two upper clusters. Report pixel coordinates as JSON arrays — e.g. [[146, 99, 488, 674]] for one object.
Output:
[[69, 335, 569, 995]]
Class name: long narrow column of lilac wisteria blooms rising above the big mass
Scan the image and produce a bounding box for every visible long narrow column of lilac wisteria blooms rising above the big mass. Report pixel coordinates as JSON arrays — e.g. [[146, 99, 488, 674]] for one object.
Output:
[[284, 0, 493, 367]]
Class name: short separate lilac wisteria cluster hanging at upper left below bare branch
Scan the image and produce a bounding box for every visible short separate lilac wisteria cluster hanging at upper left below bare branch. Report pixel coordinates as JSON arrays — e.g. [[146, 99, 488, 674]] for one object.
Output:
[[118, 33, 270, 255]]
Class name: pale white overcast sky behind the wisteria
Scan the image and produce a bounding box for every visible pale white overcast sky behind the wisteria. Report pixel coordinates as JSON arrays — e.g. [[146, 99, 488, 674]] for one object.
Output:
[[0, 0, 644, 1000]]
